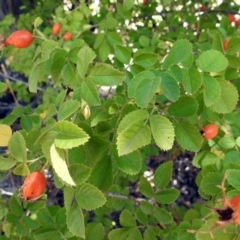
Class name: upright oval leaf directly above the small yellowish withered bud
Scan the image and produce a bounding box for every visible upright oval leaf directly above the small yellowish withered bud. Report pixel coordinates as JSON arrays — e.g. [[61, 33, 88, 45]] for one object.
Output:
[[81, 78, 101, 106]]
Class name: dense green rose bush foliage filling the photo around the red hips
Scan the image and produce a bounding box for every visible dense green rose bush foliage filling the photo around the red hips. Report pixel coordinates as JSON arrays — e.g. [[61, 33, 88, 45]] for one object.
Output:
[[0, 0, 240, 240]]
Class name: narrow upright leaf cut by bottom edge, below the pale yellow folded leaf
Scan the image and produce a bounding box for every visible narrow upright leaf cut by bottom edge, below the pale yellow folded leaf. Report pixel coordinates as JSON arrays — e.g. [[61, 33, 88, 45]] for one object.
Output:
[[67, 203, 85, 239]]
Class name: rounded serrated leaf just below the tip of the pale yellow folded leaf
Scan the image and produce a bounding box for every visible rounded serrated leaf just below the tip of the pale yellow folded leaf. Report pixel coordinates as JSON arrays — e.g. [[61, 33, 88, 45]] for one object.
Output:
[[75, 183, 106, 210]]
